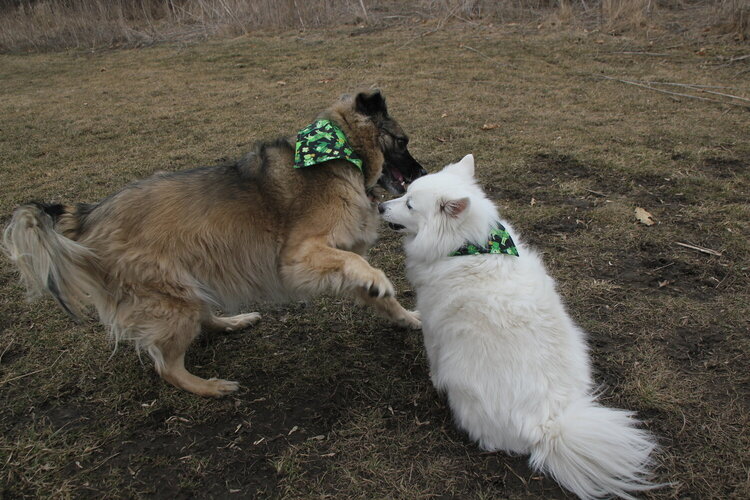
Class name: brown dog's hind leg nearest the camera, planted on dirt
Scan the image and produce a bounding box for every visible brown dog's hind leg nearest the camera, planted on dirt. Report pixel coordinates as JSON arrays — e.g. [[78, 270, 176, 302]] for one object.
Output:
[[150, 308, 239, 397]]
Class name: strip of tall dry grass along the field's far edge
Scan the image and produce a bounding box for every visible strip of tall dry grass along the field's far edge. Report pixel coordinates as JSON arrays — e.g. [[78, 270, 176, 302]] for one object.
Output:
[[0, 0, 749, 52]]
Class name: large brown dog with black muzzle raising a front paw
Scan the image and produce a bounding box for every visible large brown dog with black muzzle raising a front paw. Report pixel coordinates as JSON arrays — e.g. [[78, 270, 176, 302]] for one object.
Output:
[[4, 91, 425, 396]]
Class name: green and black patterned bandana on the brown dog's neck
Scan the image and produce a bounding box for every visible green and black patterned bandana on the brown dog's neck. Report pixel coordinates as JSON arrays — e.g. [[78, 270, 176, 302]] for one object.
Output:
[[294, 120, 362, 170]]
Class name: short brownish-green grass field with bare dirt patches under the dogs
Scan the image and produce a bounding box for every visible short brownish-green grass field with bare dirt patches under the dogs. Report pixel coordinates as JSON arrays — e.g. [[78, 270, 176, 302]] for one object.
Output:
[[0, 17, 750, 499]]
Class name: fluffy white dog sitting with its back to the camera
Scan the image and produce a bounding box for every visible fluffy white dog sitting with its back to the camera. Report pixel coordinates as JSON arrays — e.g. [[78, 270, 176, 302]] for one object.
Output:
[[379, 155, 656, 499]]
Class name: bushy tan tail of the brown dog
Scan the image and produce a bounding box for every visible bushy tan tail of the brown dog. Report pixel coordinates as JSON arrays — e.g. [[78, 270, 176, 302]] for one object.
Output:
[[3, 203, 103, 318]]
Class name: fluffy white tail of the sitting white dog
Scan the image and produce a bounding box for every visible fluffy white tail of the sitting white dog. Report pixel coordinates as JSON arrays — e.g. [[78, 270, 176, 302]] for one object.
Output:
[[529, 398, 661, 499]]
